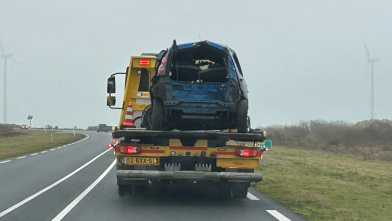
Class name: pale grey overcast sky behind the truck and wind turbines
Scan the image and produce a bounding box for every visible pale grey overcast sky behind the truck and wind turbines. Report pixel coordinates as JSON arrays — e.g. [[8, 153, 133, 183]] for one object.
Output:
[[0, 0, 392, 128]]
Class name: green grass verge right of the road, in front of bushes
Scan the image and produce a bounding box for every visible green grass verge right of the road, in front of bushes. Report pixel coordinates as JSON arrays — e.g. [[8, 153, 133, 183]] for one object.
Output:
[[257, 147, 392, 221]]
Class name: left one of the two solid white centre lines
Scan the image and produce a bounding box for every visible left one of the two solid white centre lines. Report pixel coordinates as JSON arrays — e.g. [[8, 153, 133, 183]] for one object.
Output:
[[0, 149, 110, 218]]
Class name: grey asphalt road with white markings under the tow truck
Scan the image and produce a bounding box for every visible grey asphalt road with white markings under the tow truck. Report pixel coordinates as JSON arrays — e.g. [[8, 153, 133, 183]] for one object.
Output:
[[0, 132, 305, 221]]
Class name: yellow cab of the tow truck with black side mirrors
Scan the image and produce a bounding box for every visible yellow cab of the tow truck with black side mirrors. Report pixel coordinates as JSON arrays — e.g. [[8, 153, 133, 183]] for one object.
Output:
[[107, 53, 156, 129]]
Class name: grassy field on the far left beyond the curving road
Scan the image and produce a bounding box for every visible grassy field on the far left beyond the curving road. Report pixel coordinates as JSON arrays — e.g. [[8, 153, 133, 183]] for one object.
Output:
[[0, 130, 84, 159]]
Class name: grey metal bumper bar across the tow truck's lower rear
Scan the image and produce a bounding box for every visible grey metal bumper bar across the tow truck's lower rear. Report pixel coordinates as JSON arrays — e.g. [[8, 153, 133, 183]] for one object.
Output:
[[117, 170, 263, 182]]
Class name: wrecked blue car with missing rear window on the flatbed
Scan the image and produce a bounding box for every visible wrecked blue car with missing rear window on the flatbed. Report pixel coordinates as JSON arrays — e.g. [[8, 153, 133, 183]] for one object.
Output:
[[150, 40, 248, 133]]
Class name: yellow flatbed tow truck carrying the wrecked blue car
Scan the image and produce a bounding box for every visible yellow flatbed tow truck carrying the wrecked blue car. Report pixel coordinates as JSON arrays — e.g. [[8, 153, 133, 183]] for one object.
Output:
[[107, 52, 271, 198]]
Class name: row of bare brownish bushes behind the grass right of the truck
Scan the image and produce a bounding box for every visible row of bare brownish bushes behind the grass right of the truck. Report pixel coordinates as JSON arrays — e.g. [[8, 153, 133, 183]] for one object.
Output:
[[260, 120, 392, 161]]
